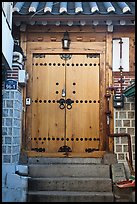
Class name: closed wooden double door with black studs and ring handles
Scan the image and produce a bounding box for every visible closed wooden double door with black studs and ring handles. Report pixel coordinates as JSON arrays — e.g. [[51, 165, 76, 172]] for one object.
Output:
[[30, 53, 101, 155]]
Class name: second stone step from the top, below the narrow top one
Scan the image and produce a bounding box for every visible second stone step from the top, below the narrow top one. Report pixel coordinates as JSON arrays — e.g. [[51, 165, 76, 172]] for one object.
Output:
[[28, 164, 110, 178]]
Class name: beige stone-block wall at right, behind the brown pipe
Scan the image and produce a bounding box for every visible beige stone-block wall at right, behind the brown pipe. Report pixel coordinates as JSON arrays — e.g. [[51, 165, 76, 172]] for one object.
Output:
[[114, 97, 135, 175]]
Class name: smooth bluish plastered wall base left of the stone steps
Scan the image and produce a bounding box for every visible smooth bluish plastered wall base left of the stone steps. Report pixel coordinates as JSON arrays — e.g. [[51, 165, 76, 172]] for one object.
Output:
[[2, 164, 28, 202]]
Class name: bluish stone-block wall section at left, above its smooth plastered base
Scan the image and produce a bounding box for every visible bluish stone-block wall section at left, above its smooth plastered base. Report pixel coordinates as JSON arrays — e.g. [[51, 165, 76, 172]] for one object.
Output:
[[2, 90, 22, 163]]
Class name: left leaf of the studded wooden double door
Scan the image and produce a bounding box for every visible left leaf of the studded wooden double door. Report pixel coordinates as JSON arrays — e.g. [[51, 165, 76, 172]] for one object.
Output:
[[32, 55, 65, 152]]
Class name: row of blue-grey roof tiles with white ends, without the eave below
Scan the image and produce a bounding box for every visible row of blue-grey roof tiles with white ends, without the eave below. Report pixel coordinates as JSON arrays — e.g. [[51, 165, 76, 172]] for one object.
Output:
[[13, 2, 135, 15]]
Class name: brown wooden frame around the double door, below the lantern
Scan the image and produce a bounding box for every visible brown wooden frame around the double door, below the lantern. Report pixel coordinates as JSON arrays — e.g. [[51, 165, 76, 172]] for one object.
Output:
[[24, 42, 110, 155]]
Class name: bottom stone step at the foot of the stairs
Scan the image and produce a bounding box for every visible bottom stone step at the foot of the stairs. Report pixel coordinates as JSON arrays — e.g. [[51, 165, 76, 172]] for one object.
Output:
[[27, 191, 114, 202]]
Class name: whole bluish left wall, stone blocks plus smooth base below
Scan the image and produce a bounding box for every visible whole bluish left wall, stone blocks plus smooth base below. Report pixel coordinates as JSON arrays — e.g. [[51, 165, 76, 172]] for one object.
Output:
[[2, 89, 28, 202]]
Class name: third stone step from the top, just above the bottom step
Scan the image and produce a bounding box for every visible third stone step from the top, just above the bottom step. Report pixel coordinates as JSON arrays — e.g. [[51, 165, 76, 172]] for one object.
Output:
[[28, 177, 112, 192]]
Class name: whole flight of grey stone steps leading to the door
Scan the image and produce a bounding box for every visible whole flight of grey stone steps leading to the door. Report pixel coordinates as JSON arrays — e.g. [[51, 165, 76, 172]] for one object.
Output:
[[27, 158, 114, 202]]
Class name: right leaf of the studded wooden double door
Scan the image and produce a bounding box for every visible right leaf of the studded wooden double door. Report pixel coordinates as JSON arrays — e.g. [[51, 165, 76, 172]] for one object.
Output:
[[66, 55, 99, 153]]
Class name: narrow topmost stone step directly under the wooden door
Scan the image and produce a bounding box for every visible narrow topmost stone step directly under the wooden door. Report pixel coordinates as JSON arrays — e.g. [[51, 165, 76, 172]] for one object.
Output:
[[28, 157, 102, 164]]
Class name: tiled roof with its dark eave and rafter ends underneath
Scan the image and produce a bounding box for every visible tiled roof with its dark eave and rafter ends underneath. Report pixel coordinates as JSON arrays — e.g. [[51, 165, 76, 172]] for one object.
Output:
[[13, 2, 135, 26]]
